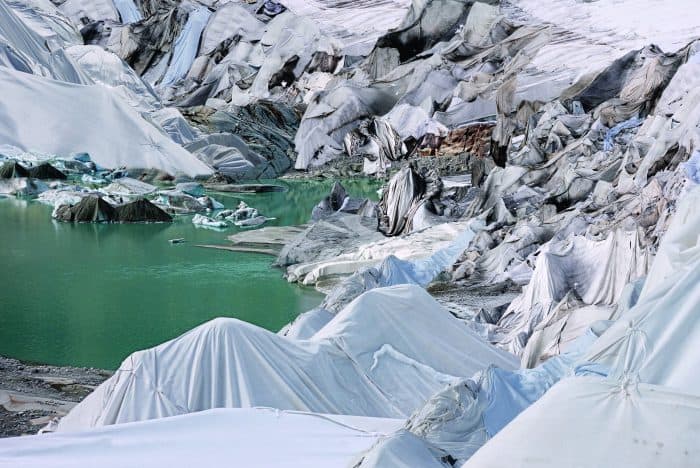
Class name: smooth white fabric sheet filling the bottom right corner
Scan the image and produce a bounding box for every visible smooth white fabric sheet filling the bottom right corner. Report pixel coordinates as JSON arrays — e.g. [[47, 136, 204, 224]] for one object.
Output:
[[462, 377, 700, 468]]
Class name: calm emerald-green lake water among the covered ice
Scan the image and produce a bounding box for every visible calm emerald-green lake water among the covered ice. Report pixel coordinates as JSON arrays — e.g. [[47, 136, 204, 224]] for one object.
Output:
[[0, 180, 377, 369]]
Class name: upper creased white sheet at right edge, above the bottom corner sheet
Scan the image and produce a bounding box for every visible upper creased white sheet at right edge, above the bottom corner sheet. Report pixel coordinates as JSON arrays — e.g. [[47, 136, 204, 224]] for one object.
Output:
[[587, 187, 700, 394]]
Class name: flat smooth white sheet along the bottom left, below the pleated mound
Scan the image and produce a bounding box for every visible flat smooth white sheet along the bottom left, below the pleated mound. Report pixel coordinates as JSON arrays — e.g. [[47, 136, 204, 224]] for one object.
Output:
[[0, 408, 403, 468]]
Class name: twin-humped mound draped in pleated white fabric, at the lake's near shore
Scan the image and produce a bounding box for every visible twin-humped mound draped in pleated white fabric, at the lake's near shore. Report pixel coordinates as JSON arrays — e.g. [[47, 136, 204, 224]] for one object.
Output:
[[58, 285, 517, 431]]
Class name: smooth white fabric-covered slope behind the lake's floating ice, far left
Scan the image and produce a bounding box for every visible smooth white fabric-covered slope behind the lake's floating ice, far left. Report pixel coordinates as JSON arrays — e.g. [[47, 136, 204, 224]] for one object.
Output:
[[0, 67, 212, 176]]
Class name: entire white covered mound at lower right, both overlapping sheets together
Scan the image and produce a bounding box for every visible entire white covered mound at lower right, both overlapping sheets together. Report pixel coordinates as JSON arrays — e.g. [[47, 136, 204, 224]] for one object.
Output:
[[464, 187, 700, 468]]
